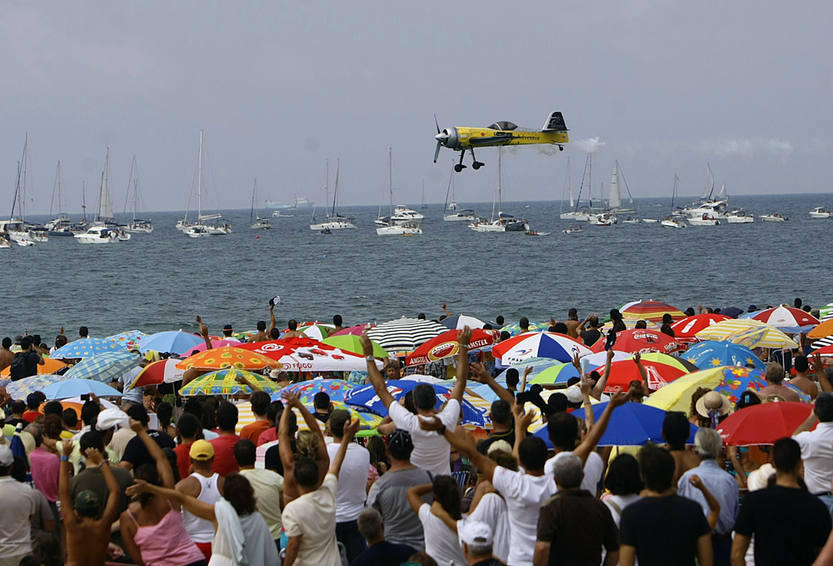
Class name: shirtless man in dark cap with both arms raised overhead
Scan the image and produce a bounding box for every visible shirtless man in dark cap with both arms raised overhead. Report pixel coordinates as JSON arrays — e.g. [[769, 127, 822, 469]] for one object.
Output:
[[58, 440, 121, 566]]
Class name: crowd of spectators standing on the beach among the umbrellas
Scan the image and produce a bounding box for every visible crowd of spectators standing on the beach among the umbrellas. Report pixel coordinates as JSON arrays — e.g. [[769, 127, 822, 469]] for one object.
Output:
[[0, 305, 833, 566]]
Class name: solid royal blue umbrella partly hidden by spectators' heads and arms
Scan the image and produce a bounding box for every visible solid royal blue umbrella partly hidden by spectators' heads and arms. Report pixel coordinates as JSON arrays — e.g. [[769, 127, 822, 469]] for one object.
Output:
[[535, 403, 698, 448]]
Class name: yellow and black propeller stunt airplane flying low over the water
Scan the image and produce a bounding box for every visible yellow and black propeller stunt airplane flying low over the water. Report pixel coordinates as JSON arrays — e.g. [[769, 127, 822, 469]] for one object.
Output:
[[434, 112, 570, 173]]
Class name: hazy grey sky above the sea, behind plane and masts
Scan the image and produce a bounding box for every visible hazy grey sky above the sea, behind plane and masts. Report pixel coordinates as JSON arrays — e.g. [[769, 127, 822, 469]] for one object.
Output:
[[0, 0, 833, 213]]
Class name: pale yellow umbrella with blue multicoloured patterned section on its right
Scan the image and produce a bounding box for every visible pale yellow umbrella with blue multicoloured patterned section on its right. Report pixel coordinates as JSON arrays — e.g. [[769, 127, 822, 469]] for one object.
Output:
[[645, 366, 767, 414]]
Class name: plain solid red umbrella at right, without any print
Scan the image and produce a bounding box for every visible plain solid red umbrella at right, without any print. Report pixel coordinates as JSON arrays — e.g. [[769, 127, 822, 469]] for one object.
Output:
[[717, 403, 813, 446]]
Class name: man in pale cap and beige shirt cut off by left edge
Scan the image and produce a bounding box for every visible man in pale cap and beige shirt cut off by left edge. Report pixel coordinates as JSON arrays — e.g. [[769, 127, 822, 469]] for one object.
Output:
[[0, 444, 35, 566]]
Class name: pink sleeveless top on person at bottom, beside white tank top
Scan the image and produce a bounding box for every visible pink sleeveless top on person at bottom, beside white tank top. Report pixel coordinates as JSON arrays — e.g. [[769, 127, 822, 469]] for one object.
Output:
[[127, 503, 205, 566]]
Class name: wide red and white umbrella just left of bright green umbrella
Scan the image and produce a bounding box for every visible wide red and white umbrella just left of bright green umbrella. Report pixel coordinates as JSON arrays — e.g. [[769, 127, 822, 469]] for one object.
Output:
[[240, 336, 383, 372]]
